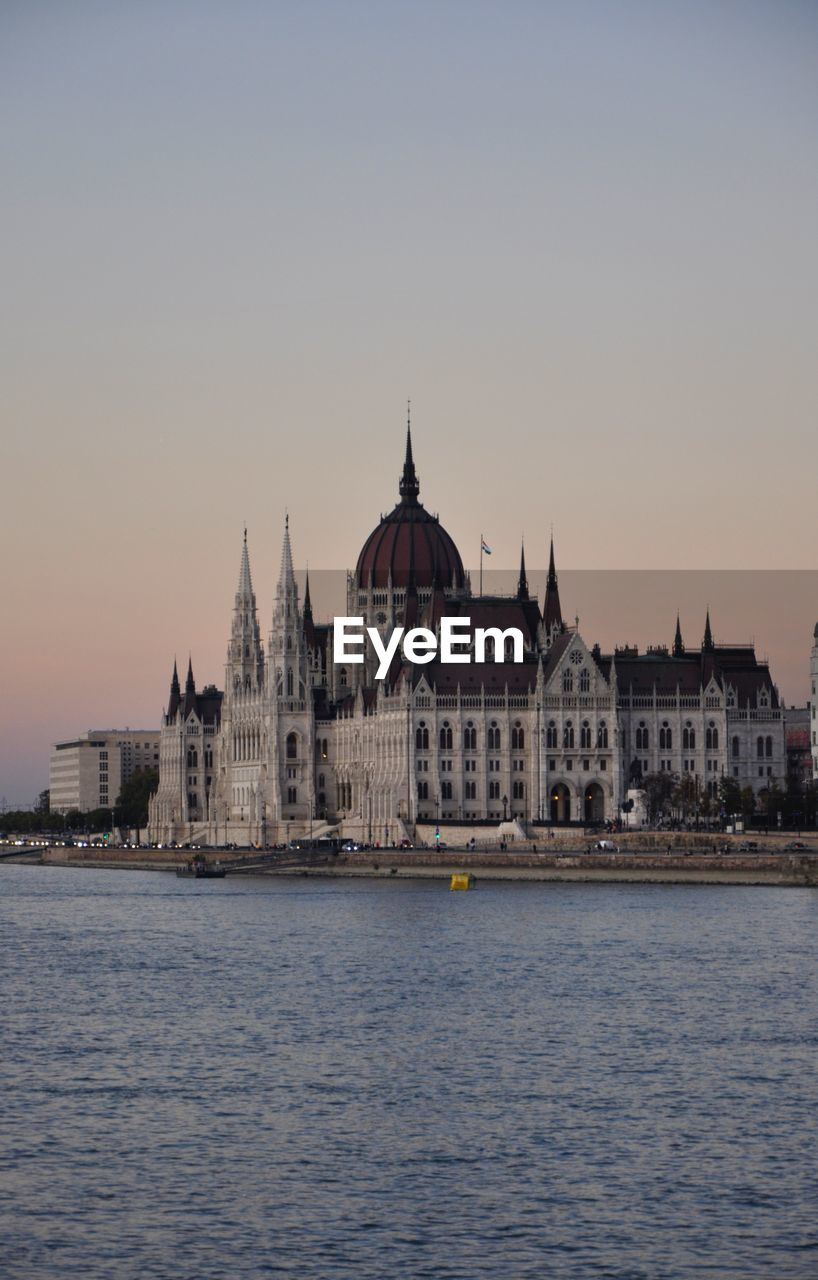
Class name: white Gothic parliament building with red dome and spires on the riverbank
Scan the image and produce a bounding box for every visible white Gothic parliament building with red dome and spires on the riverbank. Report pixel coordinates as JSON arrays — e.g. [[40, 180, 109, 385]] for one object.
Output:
[[150, 429, 786, 845]]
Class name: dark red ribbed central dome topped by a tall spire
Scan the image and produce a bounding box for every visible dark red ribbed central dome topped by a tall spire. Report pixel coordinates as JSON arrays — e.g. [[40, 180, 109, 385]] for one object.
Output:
[[355, 428, 465, 590]]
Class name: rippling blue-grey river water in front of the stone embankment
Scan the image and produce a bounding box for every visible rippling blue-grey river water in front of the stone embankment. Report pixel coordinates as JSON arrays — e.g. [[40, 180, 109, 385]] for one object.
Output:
[[0, 865, 818, 1280]]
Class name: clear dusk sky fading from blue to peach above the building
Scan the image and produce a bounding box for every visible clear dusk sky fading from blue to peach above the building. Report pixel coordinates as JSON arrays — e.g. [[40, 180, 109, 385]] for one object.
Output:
[[0, 0, 818, 804]]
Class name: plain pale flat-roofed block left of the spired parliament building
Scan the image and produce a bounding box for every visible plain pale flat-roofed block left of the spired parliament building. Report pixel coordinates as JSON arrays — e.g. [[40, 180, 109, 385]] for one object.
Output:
[[49, 728, 160, 813]]
